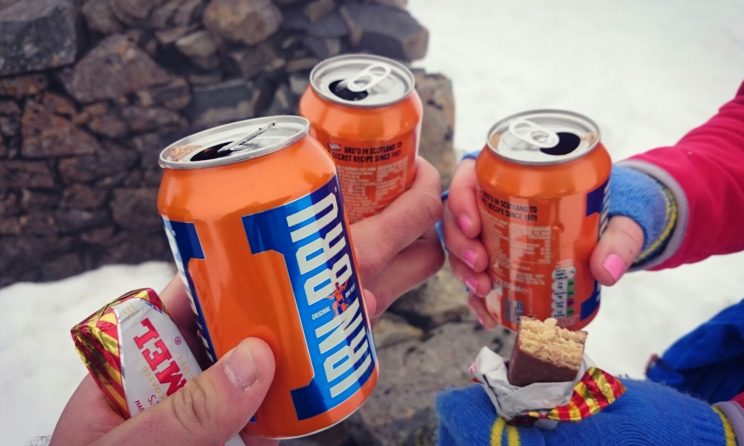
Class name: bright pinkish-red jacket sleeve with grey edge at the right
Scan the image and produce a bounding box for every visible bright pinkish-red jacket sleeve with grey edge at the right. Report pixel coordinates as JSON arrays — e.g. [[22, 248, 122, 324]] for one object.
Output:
[[621, 79, 744, 270]]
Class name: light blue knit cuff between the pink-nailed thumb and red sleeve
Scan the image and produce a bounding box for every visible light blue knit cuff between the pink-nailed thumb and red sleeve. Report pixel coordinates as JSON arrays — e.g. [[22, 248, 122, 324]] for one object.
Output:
[[609, 165, 677, 264]]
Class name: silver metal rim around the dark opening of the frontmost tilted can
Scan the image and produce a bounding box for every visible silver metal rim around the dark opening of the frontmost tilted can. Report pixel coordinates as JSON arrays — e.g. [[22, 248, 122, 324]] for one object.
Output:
[[158, 115, 310, 170]]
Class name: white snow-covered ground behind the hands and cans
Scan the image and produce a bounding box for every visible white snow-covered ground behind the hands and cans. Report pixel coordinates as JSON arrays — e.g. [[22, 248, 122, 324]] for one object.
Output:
[[0, 0, 744, 445]]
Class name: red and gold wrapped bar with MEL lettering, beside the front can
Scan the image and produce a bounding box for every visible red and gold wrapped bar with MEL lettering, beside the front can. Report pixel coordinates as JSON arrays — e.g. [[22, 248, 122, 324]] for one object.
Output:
[[71, 289, 201, 418]]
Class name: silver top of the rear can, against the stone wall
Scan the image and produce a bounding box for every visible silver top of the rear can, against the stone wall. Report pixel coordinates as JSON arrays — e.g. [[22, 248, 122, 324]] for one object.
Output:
[[310, 54, 416, 108]]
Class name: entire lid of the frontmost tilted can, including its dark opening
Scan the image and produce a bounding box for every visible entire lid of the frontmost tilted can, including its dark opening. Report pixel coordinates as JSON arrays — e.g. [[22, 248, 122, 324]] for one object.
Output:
[[160, 116, 309, 169]]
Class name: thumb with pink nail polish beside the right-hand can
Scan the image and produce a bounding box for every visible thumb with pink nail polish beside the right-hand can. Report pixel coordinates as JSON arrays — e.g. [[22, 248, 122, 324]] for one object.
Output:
[[589, 215, 643, 285]]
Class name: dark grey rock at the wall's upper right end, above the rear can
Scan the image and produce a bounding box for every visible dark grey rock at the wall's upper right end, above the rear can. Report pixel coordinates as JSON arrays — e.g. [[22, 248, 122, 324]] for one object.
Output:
[[342, 3, 429, 61]]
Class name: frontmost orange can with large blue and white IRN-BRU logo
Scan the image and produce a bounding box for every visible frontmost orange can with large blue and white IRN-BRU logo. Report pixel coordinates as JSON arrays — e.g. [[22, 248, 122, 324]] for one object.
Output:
[[158, 116, 378, 438]]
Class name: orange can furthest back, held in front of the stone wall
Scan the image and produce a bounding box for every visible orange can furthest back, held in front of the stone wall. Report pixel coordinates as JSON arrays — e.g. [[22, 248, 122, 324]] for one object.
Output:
[[300, 54, 423, 223]]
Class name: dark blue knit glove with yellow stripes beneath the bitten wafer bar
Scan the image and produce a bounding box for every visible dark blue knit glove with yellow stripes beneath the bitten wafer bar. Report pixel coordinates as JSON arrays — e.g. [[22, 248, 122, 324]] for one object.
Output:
[[436, 379, 736, 446]]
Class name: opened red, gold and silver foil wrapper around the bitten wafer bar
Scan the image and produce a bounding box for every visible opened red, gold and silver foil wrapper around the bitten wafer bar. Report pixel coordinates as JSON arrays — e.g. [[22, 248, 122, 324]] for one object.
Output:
[[470, 347, 625, 428]]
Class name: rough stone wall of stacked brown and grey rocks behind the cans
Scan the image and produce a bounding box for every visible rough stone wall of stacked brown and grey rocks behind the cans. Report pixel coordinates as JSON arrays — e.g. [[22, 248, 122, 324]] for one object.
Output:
[[0, 0, 510, 445]]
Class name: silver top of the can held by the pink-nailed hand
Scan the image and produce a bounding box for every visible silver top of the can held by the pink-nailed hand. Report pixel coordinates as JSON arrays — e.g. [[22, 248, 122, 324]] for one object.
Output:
[[487, 109, 600, 165]]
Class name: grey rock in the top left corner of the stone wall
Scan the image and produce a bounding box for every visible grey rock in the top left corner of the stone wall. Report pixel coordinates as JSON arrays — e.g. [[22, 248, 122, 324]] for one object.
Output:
[[0, 0, 77, 76]]
